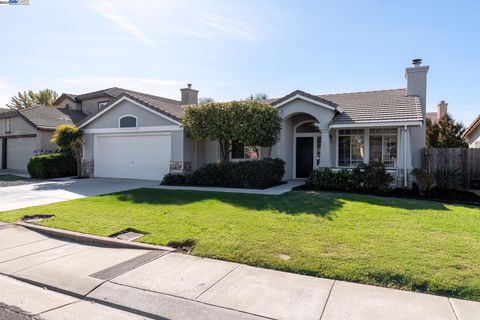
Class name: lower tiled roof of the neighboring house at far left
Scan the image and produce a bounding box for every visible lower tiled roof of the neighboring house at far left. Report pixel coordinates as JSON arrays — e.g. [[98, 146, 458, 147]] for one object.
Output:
[[16, 105, 87, 129]]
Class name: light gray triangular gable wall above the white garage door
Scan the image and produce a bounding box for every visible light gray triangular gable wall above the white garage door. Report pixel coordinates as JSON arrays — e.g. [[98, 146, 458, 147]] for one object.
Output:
[[84, 99, 178, 129]]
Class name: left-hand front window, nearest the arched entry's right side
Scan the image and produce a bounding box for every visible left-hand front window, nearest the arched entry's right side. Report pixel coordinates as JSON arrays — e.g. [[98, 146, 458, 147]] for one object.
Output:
[[338, 129, 365, 167]]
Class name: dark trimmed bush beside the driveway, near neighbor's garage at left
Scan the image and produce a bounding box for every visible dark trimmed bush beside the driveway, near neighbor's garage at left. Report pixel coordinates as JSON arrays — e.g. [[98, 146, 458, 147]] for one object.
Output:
[[27, 153, 77, 179]]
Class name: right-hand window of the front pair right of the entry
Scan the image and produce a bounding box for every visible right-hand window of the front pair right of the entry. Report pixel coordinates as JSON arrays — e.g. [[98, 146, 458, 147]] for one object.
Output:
[[369, 128, 398, 167]]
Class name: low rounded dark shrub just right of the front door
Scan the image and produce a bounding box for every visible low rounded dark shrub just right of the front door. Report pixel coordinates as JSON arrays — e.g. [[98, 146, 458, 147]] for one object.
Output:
[[307, 168, 353, 191]]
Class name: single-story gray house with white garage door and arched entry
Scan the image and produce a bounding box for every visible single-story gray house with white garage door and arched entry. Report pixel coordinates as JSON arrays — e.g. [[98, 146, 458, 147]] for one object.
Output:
[[74, 59, 429, 185]]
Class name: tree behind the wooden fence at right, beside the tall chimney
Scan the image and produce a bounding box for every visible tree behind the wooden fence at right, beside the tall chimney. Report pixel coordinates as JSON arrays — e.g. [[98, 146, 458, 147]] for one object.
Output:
[[427, 114, 468, 148]]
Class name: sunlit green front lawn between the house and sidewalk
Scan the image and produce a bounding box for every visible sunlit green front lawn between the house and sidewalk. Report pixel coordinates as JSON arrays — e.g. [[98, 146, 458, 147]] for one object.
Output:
[[0, 189, 480, 300]]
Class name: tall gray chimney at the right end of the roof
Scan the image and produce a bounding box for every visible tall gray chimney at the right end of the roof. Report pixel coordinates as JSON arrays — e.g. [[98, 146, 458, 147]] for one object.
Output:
[[405, 59, 430, 119]]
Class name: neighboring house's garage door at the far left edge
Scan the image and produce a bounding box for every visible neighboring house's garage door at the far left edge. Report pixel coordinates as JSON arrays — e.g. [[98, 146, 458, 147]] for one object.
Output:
[[7, 138, 37, 170]]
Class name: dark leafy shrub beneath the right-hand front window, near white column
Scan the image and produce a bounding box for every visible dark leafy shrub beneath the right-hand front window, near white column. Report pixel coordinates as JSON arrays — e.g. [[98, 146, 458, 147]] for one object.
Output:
[[352, 161, 394, 193]]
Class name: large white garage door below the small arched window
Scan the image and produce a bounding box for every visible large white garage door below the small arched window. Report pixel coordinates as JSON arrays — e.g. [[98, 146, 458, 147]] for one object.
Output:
[[94, 133, 171, 180]]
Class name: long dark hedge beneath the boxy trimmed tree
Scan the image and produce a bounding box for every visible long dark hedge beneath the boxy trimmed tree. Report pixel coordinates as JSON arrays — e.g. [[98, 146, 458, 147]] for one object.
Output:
[[162, 158, 285, 189]]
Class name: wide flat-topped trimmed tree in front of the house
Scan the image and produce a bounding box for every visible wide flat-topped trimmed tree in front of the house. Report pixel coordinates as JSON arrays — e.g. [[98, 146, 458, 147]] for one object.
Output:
[[183, 101, 282, 161]]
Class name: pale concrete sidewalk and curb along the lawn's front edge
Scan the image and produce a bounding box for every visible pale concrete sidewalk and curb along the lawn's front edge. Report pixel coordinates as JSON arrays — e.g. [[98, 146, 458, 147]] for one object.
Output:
[[0, 224, 480, 320]]
